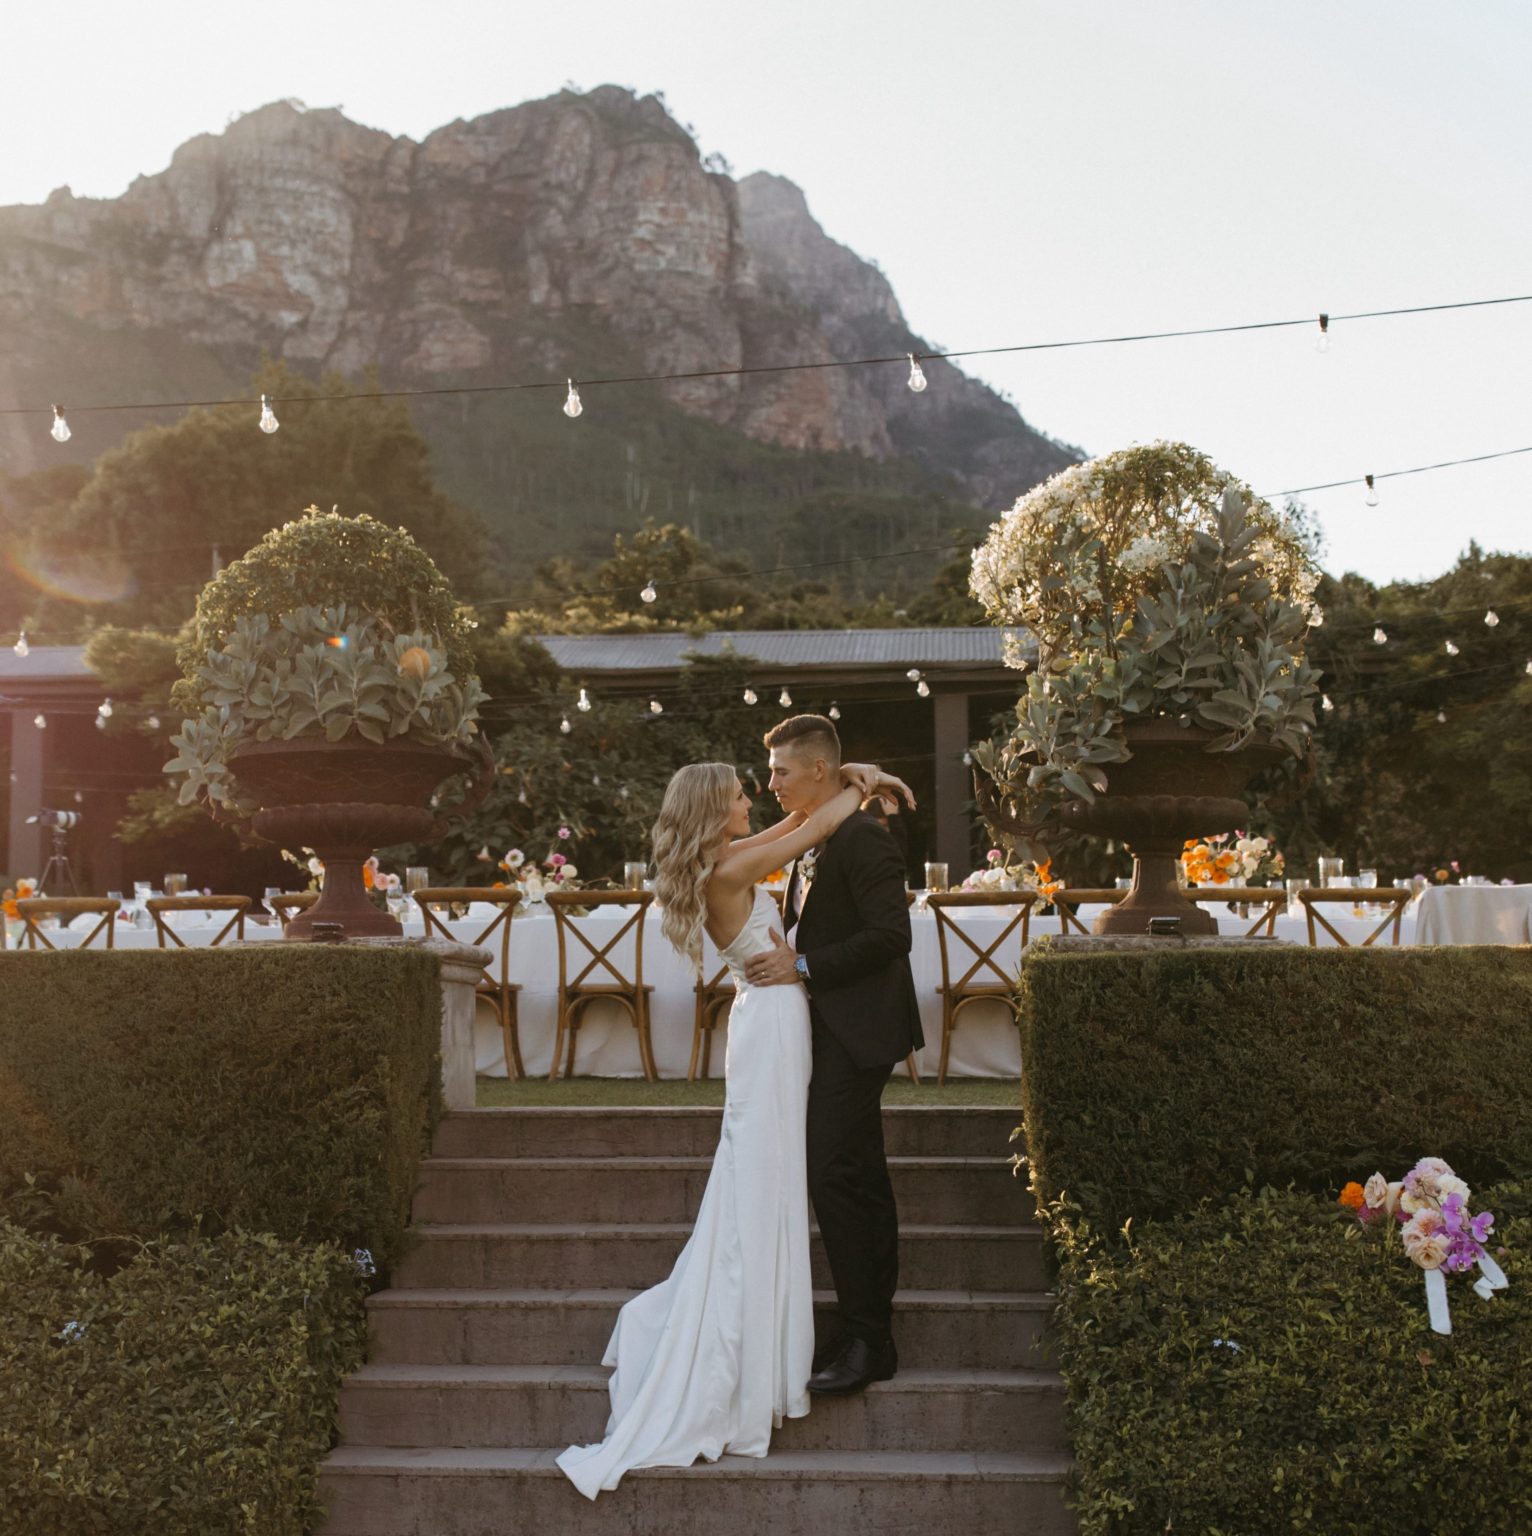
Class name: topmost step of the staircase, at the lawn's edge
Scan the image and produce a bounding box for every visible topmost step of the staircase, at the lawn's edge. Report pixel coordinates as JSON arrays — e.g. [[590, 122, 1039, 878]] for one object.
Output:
[[433, 1104, 1022, 1157]]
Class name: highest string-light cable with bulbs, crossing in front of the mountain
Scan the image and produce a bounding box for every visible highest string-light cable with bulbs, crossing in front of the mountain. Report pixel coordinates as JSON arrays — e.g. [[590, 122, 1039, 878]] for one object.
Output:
[[11, 293, 1532, 427]]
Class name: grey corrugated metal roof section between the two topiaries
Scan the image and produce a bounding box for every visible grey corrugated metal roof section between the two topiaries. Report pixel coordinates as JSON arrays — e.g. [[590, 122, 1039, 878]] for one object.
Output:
[[536, 628, 1005, 673]]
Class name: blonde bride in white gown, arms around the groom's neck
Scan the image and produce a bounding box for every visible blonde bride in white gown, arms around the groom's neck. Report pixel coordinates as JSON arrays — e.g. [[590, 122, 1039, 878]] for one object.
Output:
[[558, 763, 914, 1499]]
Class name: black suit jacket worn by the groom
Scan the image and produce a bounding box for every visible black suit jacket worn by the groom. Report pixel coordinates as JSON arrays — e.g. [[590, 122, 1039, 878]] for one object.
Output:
[[784, 811, 925, 1068]]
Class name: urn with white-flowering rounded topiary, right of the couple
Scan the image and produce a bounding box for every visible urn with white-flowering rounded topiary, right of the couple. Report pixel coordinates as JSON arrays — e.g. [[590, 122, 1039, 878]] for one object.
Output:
[[971, 442, 1323, 934]]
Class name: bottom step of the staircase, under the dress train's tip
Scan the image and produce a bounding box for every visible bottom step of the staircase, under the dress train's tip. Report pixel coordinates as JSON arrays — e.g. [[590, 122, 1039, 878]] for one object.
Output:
[[320, 1445, 1074, 1536]]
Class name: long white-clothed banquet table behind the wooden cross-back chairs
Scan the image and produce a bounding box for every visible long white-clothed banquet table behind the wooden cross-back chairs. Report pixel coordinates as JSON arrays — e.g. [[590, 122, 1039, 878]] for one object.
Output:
[[17, 888, 1432, 1078]]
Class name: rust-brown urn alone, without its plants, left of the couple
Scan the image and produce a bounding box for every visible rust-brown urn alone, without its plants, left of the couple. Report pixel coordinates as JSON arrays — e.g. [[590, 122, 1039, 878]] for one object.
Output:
[[229, 737, 495, 940]]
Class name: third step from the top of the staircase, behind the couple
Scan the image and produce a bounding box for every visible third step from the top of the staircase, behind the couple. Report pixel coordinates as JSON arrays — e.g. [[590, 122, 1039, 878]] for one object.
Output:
[[393, 1223, 1048, 1290]]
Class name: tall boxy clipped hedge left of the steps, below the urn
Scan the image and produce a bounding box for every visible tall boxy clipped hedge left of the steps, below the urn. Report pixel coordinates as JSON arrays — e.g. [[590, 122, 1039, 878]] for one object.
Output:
[[0, 945, 441, 1267]]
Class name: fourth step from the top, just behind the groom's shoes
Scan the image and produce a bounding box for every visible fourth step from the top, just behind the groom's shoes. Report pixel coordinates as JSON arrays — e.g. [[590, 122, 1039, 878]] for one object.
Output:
[[367, 1287, 1053, 1370]]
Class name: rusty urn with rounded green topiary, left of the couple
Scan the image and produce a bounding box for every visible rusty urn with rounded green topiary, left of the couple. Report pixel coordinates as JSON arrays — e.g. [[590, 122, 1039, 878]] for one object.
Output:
[[166, 507, 493, 938]]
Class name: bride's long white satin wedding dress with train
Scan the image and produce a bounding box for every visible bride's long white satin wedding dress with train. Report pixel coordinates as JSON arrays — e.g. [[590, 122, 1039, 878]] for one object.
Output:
[[558, 889, 814, 1499]]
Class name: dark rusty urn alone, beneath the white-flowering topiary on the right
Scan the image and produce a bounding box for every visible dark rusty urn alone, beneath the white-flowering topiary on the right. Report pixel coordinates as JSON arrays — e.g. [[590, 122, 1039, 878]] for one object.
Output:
[[1059, 720, 1286, 934]]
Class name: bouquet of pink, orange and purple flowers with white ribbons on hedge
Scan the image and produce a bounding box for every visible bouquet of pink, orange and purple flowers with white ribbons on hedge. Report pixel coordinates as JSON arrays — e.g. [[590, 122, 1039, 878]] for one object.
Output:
[[1340, 1157, 1510, 1333]]
